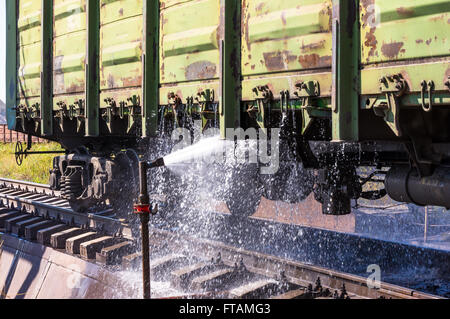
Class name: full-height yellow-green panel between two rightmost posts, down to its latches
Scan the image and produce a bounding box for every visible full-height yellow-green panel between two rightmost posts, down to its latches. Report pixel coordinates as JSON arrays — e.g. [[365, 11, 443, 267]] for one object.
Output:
[[241, 0, 332, 133]]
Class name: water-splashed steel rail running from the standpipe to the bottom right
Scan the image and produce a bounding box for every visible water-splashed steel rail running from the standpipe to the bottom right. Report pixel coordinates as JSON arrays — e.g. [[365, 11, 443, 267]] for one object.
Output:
[[150, 229, 443, 299]]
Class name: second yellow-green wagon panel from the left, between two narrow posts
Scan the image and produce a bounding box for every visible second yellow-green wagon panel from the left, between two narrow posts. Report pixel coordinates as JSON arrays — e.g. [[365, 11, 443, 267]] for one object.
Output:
[[53, 0, 87, 97]]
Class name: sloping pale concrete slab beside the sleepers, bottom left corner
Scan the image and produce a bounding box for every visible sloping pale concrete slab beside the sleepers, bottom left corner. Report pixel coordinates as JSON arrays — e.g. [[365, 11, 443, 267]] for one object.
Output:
[[0, 233, 140, 299]]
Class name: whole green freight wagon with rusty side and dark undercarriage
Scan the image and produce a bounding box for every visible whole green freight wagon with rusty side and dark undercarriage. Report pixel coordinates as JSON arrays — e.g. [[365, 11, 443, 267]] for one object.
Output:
[[6, 0, 450, 215]]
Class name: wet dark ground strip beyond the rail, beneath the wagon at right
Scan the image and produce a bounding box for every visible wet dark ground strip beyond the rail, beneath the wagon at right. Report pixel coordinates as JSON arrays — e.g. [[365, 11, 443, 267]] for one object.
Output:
[[153, 208, 450, 297]]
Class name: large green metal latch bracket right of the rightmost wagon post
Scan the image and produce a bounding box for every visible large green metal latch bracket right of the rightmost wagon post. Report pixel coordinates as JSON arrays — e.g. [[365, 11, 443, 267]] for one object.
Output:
[[373, 74, 408, 137]]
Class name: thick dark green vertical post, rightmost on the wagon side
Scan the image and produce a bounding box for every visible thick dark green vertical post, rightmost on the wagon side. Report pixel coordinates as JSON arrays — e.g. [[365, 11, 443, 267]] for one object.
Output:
[[332, 0, 360, 142]]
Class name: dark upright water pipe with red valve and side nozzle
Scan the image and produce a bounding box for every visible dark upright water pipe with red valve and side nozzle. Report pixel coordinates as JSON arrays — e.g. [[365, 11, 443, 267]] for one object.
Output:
[[134, 158, 165, 299]]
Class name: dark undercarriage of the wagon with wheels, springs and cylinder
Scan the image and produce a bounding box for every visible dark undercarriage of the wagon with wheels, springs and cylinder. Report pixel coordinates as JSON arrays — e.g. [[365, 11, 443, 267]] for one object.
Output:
[[38, 101, 450, 216]]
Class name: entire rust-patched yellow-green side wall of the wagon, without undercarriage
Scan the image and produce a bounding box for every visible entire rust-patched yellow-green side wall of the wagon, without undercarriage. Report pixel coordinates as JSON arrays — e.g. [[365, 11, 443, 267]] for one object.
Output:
[[7, 0, 450, 148]]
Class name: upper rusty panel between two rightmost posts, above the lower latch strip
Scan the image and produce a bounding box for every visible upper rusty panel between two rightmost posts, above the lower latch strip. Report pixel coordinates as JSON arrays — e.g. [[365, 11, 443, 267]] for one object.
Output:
[[242, 0, 332, 76]]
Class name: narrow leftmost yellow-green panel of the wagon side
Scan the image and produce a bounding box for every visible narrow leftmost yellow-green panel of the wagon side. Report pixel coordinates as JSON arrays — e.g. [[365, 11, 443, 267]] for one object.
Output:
[[17, 0, 42, 100]]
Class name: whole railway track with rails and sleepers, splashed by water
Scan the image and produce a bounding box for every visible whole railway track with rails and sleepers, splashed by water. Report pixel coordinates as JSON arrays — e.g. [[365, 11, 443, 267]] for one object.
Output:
[[0, 179, 439, 299]]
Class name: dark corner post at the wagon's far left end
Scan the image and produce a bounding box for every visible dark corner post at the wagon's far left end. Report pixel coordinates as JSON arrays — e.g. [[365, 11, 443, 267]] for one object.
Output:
[[3, 1, 17, 130]]
